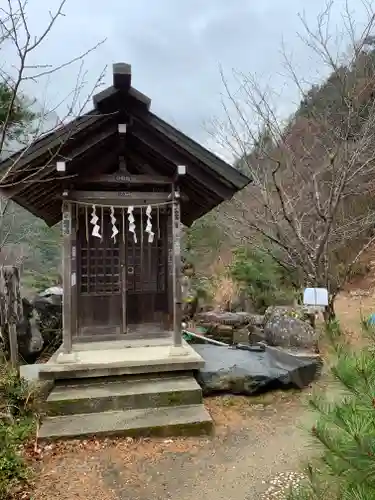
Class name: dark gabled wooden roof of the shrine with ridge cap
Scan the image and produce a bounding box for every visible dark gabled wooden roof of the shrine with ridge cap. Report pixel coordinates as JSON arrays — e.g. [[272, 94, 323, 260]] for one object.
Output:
[[0, 63, 250, 225]]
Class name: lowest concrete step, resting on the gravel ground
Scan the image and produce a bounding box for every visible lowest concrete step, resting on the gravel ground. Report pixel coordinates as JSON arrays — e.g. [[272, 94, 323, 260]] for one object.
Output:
[[39, 404, 212, 440]]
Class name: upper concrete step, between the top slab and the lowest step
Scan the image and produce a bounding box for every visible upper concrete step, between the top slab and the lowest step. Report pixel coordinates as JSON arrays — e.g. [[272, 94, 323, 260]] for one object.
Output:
[[46, 376, 206, 416]]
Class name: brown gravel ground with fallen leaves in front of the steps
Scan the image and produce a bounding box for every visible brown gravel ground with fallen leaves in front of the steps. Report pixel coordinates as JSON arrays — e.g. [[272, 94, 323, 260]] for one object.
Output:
[[32, 392, 318, 500]]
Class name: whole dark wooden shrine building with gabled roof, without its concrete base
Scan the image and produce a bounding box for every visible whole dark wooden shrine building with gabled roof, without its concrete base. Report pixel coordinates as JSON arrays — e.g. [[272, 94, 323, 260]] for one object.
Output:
[[0, 63, 253, 364]]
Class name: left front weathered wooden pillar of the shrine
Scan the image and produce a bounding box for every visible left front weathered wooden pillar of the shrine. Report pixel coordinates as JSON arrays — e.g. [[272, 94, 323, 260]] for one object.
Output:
[[62, 197, 73, 354]]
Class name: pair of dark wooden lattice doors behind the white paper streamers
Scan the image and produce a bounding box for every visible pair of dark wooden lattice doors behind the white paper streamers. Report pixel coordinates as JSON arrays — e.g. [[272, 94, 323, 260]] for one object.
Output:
[[77, 208, 170, 336]]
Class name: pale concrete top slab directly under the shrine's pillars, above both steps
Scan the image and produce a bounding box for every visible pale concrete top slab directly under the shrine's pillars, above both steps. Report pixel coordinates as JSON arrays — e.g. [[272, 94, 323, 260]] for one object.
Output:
[[39, 340, 204, 380]]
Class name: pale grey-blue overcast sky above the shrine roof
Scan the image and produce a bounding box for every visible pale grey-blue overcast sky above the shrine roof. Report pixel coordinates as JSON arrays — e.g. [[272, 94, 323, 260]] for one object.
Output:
[[8, 0, 374, 158]]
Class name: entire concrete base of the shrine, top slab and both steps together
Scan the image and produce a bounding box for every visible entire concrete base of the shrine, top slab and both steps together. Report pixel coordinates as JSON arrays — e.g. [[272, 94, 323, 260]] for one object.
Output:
[[36, 339, 212, 439]]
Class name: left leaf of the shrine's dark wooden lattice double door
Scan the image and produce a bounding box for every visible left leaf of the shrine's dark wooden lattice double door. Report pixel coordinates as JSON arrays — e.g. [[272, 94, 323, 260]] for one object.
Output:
[[77, 209, 125, 336]]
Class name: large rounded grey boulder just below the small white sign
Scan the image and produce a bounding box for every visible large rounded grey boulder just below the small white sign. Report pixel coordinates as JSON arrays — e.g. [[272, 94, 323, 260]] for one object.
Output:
[[264, 309, 319, 352]]
